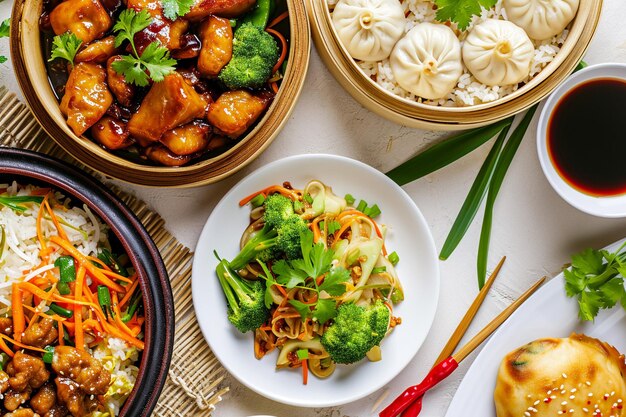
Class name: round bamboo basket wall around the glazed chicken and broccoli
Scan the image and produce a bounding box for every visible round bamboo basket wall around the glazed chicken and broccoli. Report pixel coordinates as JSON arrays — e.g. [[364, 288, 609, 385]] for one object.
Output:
[[11, 0, 311, 187]]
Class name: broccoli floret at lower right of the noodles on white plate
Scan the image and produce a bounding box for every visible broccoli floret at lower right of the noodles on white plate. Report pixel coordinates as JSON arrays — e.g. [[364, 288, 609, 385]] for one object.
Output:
[[321, 300, 390, 363]]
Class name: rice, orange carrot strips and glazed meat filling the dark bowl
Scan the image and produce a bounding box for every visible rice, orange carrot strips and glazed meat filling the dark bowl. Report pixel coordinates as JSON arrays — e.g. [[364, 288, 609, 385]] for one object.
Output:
[[0, 183, 145, 417]]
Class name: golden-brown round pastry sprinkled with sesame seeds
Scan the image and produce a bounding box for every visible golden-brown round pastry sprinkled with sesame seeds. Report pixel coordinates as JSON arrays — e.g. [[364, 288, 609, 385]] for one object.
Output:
[[494, 334, 626, 417]]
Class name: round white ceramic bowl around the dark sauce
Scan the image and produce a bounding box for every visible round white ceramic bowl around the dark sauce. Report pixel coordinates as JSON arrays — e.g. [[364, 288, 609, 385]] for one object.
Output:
[[537, 63, 626, 218]]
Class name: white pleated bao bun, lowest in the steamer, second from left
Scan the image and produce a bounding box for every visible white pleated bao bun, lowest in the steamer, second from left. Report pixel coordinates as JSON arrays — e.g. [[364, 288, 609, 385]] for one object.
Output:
[[390, 23, 463, 100]]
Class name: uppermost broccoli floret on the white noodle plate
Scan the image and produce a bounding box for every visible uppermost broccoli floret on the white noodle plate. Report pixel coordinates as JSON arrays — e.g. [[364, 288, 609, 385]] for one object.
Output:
[[230, 194, 307, 271]]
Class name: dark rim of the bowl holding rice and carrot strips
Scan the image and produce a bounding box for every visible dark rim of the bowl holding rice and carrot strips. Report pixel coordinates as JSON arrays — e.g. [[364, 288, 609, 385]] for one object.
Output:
[[0, 148, 174, 417]]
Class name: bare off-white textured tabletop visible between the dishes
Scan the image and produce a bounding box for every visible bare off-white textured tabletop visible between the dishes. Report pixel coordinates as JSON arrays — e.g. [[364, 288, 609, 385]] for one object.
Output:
[[0, 0, 626, 417]]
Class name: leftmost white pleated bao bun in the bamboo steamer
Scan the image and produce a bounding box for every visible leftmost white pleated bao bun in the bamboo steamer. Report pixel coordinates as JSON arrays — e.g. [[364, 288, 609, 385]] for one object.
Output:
[[332, 0, 406, 61]]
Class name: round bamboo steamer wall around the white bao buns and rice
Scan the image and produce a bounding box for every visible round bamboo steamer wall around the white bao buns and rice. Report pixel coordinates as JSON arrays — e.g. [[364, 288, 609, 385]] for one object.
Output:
[[306, 0, 602, 131]]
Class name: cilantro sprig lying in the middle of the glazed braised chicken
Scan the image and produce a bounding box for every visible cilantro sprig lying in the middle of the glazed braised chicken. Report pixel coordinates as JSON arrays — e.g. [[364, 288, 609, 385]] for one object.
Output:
[[112, 9, 176, 87]]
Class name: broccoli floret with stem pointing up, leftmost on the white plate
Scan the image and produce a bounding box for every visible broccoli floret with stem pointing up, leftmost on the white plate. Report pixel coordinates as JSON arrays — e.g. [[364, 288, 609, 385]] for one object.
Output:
[[216, 260, 269, 333]]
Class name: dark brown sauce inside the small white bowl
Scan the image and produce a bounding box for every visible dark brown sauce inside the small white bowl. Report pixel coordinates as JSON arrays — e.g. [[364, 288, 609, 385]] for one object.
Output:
[[548, 78, 626, 197]]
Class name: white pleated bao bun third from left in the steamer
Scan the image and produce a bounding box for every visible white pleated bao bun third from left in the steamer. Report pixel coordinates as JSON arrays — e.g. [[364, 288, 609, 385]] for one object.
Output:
[[463, 19, 535, 86]]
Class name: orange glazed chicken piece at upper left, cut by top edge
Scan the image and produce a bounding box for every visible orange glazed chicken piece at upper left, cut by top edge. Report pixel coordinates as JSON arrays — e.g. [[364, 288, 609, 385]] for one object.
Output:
[[50, 0, 113, 44]]
